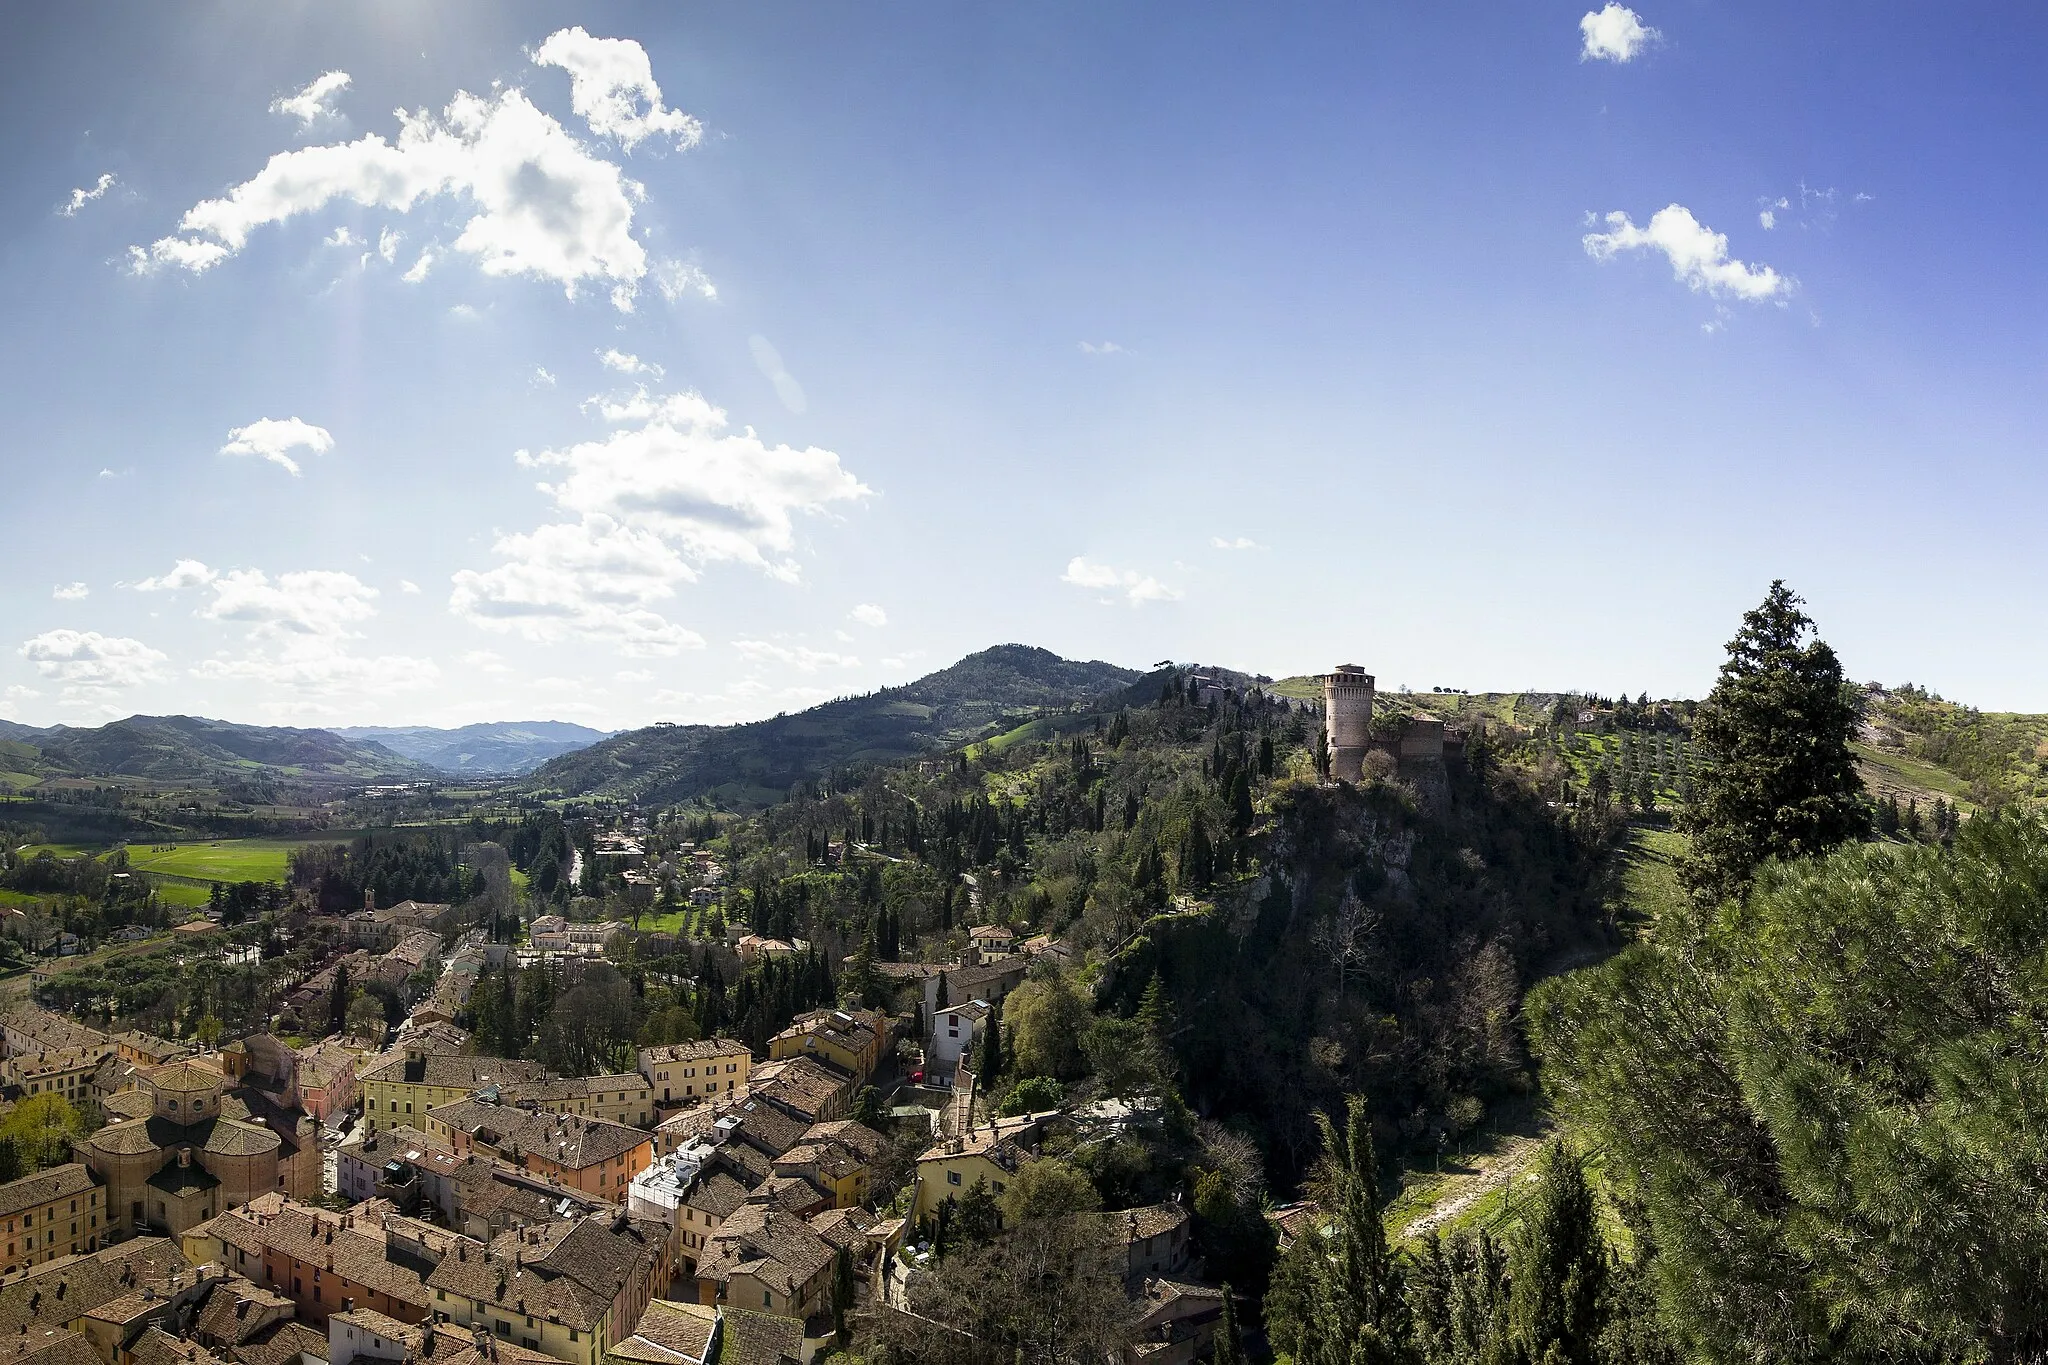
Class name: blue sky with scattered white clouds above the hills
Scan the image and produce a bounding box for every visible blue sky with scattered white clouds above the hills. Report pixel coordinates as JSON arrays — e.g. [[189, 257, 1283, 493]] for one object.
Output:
[[0, 0, 2048, 726]]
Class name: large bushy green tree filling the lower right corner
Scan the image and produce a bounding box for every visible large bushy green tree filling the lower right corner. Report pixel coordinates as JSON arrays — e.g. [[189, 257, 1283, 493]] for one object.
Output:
[[1530, 817, 2048, 1365]]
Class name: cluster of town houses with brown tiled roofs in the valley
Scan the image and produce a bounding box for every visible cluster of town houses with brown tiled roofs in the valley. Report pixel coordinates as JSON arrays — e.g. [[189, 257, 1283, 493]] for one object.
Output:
[[0, 902, 1221, 1365]]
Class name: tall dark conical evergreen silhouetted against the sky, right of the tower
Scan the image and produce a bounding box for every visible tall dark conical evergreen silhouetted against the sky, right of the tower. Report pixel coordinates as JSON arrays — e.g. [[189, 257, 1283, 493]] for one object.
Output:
[[1679, 579, 1866, 905]]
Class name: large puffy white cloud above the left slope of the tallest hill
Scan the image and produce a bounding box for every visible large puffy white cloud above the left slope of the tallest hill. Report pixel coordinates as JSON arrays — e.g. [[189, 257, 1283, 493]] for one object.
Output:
[[449, 391, 872, 655]]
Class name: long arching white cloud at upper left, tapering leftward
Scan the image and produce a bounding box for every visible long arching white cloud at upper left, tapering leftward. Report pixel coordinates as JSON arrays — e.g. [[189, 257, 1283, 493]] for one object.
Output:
[[129, 90, 647, 307]]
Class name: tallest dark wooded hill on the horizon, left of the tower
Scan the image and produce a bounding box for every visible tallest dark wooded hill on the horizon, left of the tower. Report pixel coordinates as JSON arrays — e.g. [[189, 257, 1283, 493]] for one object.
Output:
[[528, 645, 1145, 806]]
